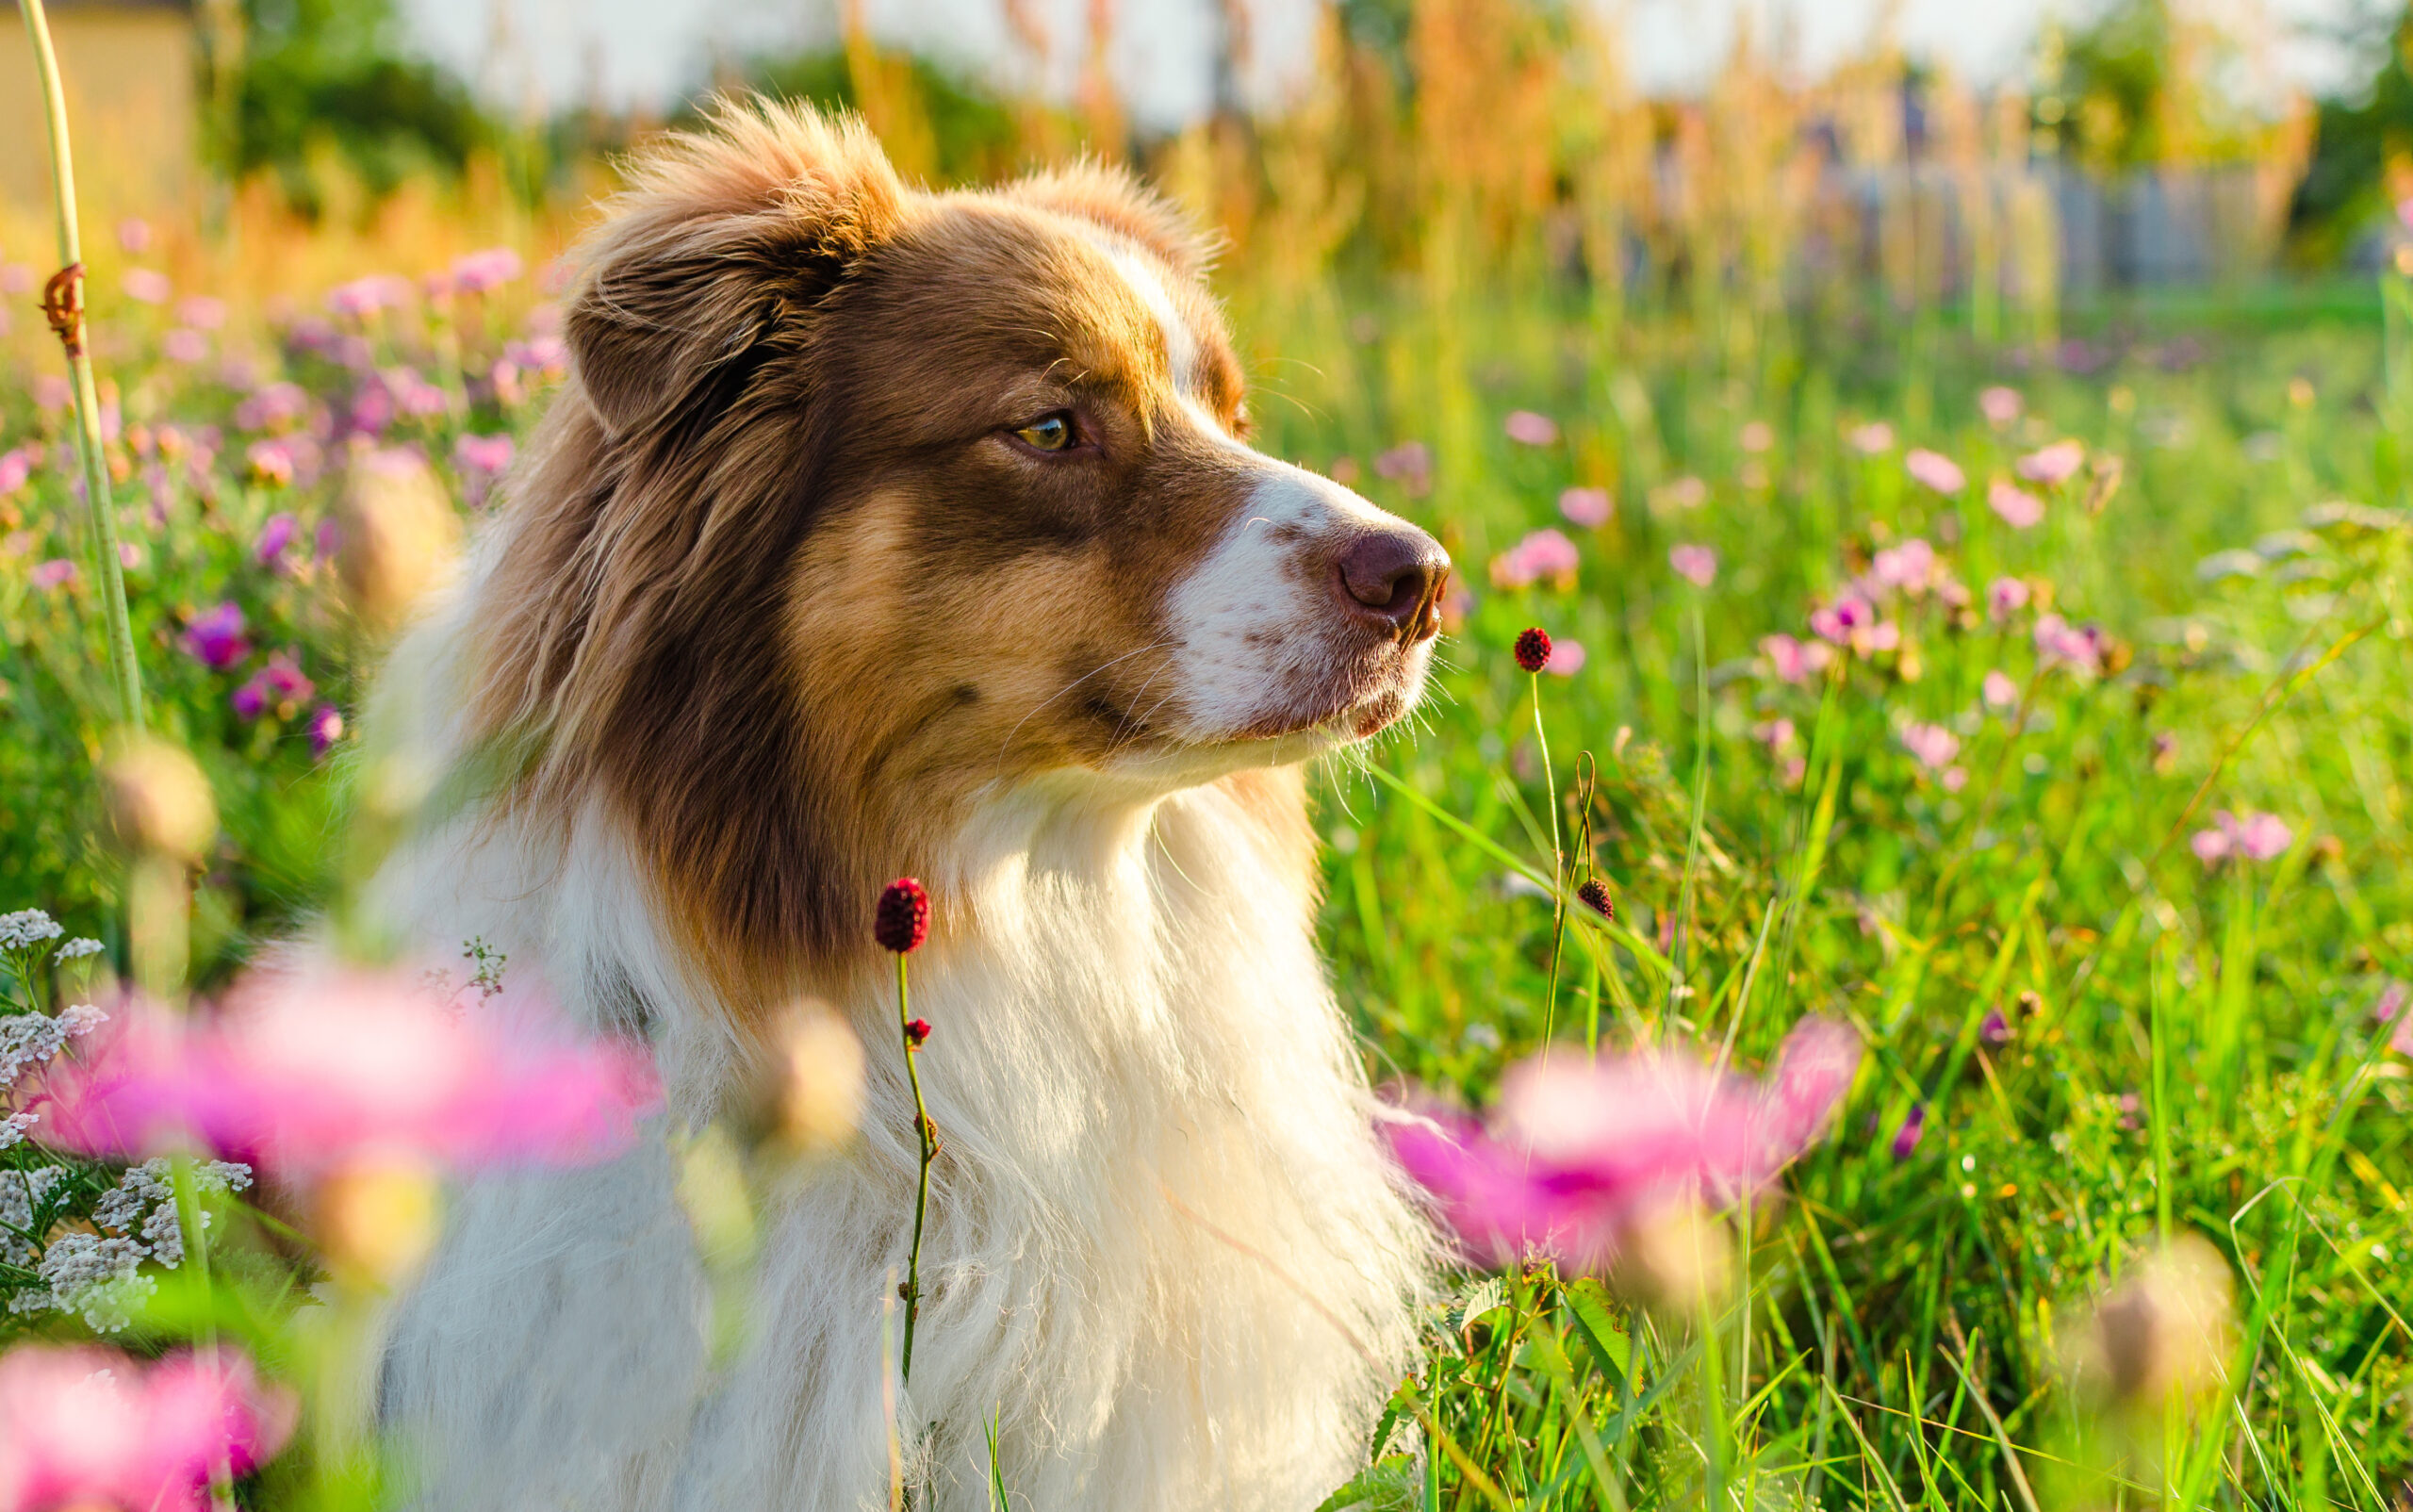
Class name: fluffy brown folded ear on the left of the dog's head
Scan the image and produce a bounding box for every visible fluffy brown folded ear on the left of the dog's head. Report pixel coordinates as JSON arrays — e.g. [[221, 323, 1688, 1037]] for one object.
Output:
[[567, 101, 905, 436]]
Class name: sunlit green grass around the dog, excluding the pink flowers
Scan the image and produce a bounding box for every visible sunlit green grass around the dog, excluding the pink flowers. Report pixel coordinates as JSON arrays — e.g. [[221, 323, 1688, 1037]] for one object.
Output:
[[0, 115, 2413, 1512]]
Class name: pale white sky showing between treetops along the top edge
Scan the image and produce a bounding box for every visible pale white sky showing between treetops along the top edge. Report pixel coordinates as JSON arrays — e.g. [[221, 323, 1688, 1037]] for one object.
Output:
[[403, 0, 2370, 125]]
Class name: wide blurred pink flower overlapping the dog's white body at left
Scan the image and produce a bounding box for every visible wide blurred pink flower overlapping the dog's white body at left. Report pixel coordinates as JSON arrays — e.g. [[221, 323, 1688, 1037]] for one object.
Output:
[[46, 969, 661, 1179]]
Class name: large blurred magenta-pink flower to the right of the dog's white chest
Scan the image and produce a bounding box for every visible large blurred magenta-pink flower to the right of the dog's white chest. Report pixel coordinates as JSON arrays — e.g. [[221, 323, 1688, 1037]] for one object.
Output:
[[1385, 1018, 1861, 1269]]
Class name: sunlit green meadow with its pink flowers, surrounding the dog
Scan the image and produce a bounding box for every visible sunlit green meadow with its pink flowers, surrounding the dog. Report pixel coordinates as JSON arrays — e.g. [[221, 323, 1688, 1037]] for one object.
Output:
[[0, 8, 2413, 1512]]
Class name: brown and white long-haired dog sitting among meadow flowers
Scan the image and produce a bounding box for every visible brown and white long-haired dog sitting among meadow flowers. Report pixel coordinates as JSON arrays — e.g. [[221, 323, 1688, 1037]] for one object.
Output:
[[369, 107, 1448, 1512]]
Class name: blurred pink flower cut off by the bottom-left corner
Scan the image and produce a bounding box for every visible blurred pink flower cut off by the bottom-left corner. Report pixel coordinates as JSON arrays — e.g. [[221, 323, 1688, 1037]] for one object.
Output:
[[0, 1345, 294, 1512]]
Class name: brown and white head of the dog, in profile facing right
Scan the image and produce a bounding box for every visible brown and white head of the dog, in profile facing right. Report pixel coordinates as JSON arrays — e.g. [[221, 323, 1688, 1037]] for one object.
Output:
[[483, 108, 1448, 964]]
